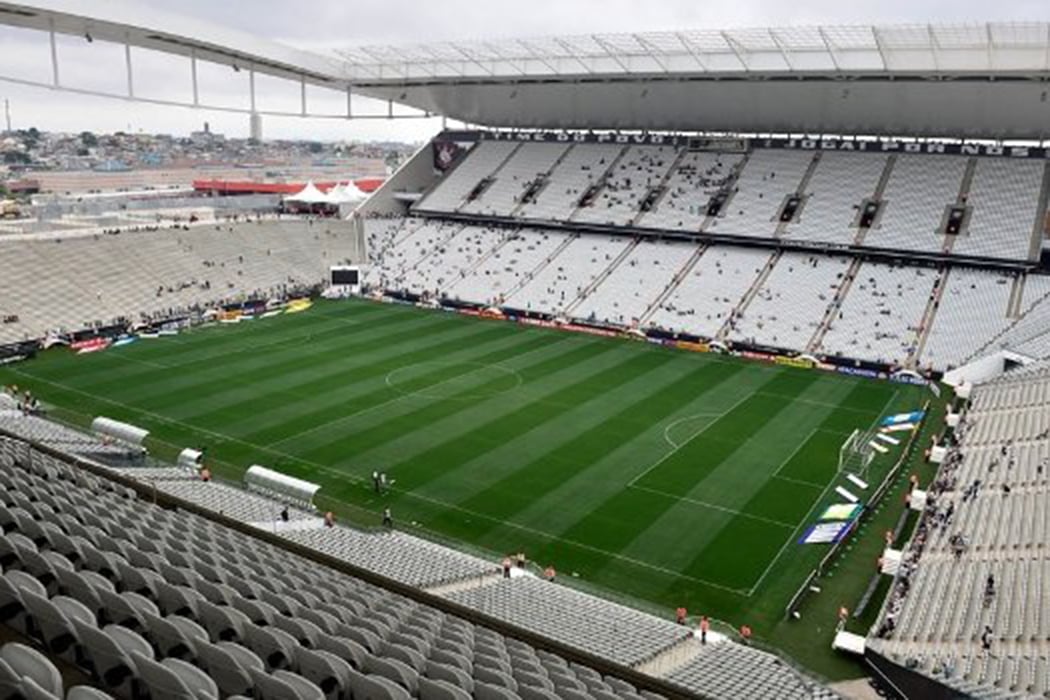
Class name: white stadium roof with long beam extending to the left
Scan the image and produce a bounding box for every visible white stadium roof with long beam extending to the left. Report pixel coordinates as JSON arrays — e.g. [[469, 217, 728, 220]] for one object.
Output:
[[6, 0, 1050, 140]]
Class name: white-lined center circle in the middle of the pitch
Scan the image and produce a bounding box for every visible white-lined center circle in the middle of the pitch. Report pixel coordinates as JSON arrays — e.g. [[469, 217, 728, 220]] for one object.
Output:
[[386, 360, 522, 401]]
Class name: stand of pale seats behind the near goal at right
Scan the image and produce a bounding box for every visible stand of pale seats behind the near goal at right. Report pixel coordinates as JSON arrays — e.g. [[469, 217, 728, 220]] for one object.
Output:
[[869, 362, 1050, 698]]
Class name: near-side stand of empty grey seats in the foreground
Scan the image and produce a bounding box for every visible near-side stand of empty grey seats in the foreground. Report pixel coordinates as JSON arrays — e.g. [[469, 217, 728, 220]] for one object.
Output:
[[0, 407, 836, 700]]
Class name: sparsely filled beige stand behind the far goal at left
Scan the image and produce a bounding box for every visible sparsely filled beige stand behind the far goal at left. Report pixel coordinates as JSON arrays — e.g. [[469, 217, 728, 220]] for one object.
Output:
[[0, 218, 360, 342]]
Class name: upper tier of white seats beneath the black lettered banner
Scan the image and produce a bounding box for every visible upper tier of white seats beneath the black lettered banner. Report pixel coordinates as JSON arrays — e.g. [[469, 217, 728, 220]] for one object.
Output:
[[416, 141, 1045, 265]]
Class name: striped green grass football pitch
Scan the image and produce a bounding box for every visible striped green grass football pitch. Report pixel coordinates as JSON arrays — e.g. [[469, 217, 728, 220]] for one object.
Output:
[[0, 301, 928, 676]]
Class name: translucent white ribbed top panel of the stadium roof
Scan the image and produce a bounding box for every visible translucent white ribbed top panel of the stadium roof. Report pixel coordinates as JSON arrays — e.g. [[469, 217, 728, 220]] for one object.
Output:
[[338, 22, 1050, 83]]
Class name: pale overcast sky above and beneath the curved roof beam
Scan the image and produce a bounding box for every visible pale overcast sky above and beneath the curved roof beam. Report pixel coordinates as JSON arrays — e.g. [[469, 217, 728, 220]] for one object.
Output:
[[0, 0, 1050, 142]]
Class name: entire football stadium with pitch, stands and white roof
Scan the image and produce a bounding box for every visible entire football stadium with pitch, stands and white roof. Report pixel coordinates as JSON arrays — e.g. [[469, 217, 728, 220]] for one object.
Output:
[[0, 0, 1050, 700]]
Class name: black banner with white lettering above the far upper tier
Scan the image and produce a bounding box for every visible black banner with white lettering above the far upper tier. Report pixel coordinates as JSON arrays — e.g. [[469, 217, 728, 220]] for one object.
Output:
[[457, 130, 1050, 160]]
